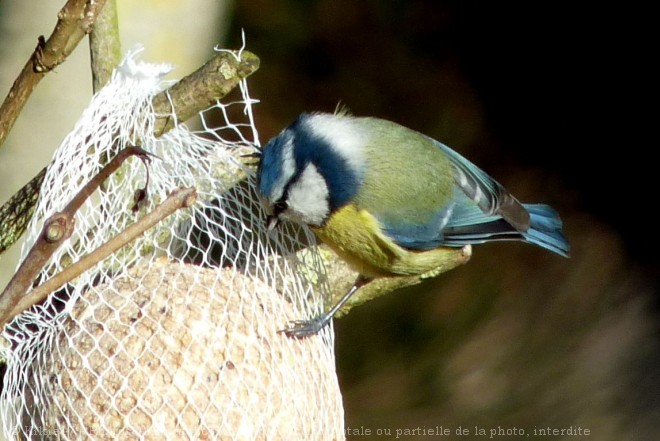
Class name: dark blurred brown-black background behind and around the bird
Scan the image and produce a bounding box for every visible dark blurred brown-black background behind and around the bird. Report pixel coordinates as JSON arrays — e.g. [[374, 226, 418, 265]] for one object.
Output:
[[230, 0, 660, 440]]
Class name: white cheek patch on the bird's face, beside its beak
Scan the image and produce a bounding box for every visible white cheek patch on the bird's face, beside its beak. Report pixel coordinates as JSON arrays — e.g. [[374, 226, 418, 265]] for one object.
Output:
[[287, 164, 330, 225]]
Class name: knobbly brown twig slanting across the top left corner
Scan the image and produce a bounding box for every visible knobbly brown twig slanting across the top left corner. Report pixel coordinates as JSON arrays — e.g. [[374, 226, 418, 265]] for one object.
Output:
[[0, 0, 105, 147]]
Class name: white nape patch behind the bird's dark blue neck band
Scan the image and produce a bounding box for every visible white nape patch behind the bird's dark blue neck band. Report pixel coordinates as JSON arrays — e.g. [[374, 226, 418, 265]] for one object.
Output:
[[306, 114, 368, 176]]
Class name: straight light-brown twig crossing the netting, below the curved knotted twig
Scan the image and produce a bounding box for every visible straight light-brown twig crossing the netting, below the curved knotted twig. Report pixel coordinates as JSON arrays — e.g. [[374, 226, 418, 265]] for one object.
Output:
[[5, 187, 197, 329]]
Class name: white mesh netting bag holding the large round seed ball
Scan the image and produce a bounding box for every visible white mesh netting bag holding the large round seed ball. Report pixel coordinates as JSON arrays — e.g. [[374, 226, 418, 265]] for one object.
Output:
[[0, 49, 344, 440]]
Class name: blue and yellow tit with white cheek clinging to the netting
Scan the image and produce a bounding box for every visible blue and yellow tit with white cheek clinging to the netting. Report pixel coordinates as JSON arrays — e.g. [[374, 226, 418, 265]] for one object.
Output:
[[257, 112, 569, 337]]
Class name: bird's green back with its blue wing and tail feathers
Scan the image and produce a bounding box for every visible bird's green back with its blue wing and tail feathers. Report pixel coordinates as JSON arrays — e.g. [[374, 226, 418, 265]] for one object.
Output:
[[356, 118, 569, 256]]
